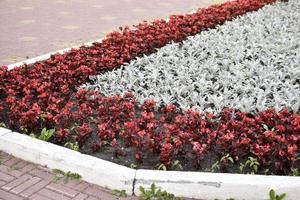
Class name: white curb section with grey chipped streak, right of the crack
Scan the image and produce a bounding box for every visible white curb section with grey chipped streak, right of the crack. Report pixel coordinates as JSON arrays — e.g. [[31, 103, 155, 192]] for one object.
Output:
[[134, 170, 300, 200]]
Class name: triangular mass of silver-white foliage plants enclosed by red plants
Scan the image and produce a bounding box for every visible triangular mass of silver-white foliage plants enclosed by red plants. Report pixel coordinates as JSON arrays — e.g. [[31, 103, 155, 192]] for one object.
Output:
[[81, 0, 300, 112]]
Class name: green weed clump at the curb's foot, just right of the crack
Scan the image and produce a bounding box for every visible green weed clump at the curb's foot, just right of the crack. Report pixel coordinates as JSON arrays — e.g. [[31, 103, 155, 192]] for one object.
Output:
[[140, 183, 181, 200]]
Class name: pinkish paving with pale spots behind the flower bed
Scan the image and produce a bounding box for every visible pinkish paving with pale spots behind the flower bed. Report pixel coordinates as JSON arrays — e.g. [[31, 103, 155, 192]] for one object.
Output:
[[0, 0, 219, 66]]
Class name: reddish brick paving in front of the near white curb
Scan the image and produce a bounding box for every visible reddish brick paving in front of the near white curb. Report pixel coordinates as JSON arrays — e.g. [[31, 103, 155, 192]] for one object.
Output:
[[0, 152, 138, 200]]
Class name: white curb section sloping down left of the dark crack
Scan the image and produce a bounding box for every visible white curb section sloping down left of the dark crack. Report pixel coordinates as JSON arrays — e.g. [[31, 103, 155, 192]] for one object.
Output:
[[0, 130, 136, 194]]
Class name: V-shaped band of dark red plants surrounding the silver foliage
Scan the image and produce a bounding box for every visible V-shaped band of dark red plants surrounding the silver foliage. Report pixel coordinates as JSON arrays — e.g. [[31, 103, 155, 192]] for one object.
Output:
[[0, 0, 300, 174]]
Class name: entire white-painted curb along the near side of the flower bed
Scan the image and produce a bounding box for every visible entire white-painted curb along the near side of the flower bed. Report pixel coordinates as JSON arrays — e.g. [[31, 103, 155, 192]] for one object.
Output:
[[0, 128, 300, 200]]
